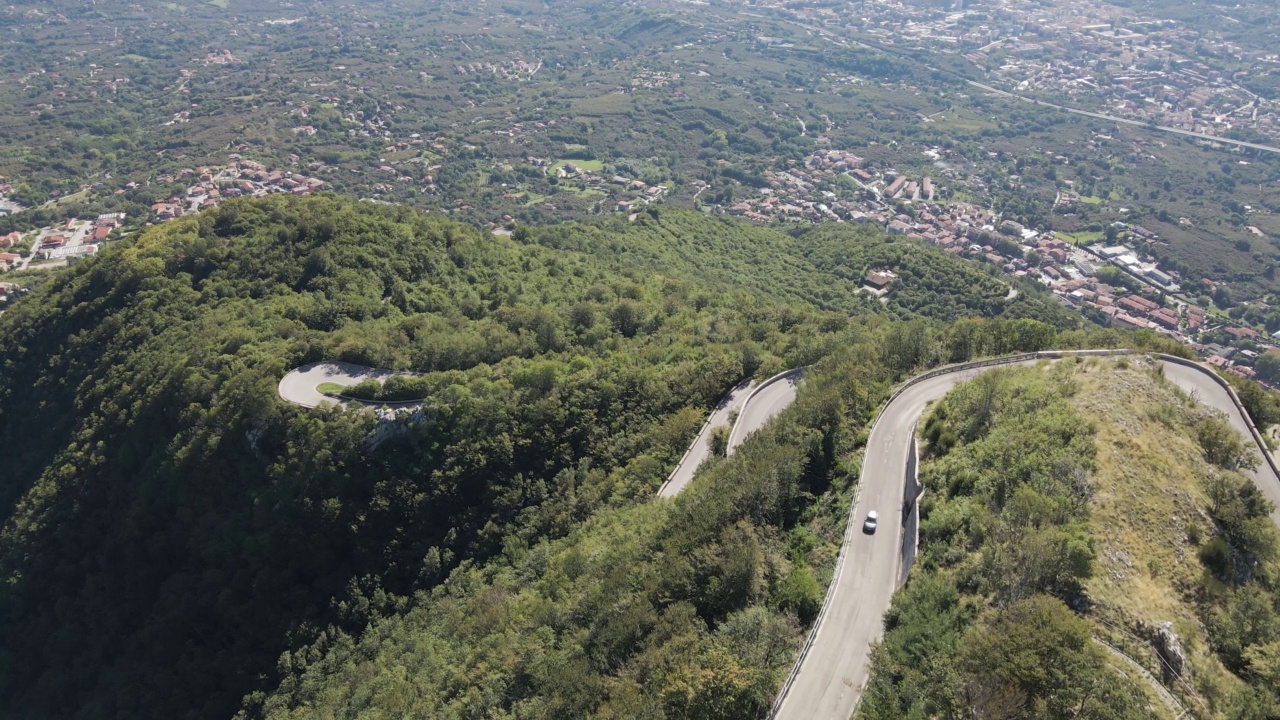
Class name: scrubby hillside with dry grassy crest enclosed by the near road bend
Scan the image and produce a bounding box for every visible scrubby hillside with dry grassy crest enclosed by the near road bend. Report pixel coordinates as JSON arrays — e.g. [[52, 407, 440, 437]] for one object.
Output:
[[859, 359, 1280, 719]]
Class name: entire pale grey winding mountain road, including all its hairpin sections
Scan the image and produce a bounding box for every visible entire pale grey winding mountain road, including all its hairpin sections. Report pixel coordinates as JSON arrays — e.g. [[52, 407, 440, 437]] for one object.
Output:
[[279, 354, 1280, 720]]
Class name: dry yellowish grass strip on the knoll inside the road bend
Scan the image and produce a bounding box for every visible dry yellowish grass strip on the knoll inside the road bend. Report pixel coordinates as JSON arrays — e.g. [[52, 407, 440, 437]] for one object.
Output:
[[1075, 361, 1240, 710]]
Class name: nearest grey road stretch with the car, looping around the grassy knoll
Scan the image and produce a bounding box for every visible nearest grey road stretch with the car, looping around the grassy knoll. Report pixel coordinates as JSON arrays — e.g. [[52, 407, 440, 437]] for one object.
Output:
[[773, 361, 1280, 720]]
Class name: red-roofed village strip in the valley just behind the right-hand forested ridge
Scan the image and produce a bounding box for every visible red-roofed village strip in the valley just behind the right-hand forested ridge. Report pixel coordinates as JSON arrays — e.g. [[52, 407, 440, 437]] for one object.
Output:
[[727, 150, 1280, 378]]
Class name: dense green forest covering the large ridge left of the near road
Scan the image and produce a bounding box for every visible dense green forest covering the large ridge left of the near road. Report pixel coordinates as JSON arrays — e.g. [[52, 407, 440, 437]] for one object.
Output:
[[0, 195, 1192, 719]]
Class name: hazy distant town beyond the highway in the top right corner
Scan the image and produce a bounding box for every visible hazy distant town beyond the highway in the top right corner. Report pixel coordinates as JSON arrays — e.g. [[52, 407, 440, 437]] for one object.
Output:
[[760, 0, 1280, 147]]
